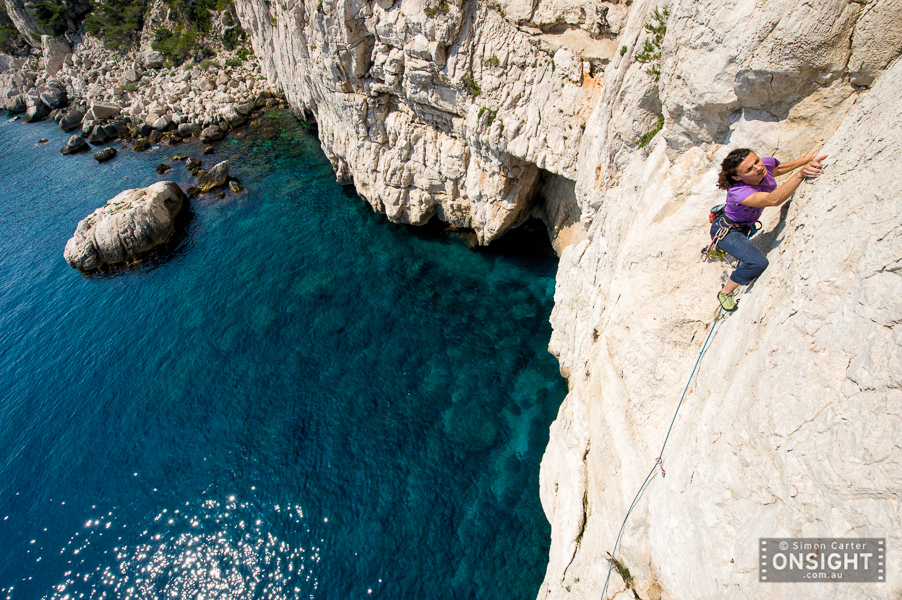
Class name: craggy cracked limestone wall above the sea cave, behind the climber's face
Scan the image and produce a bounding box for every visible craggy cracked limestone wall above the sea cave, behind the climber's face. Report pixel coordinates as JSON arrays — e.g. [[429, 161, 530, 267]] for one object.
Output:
[[237, 0, 612, 244]]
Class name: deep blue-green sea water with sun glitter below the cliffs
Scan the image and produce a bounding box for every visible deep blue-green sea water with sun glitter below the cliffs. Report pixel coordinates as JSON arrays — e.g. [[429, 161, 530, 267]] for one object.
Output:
[[0, 112, 566, 600]]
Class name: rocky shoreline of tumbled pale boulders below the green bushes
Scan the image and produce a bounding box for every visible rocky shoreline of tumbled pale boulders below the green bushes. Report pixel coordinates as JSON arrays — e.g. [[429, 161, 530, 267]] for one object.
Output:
[[0, 35, 287, 155]]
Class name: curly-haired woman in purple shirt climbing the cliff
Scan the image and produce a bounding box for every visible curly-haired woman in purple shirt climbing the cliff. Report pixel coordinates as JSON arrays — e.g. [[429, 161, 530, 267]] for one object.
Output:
[[711, 148, 827, 312]]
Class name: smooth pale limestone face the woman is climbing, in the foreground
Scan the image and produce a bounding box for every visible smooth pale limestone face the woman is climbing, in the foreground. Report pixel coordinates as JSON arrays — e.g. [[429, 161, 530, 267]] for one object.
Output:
[[539, 1, 902, 600]]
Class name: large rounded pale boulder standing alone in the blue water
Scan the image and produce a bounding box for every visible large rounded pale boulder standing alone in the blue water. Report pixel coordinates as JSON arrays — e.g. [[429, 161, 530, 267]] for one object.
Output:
[[63, 181, 185, 272]]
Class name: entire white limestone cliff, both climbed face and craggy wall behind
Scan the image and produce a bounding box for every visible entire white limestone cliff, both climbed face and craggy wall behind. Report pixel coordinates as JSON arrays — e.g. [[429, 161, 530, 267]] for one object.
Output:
[[238, 0, 902, 599]]
